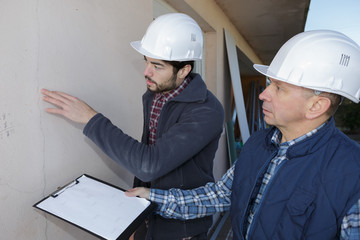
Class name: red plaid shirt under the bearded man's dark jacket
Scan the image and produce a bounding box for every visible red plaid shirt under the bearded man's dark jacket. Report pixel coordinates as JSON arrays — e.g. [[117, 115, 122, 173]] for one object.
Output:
[[149, 77, 191, 145]]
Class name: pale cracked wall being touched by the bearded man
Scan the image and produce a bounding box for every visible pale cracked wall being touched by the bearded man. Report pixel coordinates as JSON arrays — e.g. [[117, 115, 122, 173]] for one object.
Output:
[[0, 0, 153, 240]]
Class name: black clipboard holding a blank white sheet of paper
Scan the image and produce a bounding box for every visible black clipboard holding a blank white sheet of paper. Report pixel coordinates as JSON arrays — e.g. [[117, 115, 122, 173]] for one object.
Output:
[[33, 174, 156, 240]]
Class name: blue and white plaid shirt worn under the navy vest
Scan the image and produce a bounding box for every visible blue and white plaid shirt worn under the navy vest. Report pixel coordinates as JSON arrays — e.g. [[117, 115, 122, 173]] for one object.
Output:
[[150, 125, 360, 240]]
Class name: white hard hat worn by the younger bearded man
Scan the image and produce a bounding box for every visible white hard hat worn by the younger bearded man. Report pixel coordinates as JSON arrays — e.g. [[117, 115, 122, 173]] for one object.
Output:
[[130, 13, 203, 61]]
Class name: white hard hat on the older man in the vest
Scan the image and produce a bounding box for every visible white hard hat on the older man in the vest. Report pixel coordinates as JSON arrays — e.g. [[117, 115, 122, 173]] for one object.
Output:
[[254, 30, 360, 103]]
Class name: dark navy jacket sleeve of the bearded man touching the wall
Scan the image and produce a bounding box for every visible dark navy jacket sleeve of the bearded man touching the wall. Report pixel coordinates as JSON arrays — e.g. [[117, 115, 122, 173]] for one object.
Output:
[[83, 101, 224, 182]]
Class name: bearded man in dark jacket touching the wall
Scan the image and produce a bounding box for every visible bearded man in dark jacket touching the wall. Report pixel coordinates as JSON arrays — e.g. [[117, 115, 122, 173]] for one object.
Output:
[[42, 13, 224, 240]]
